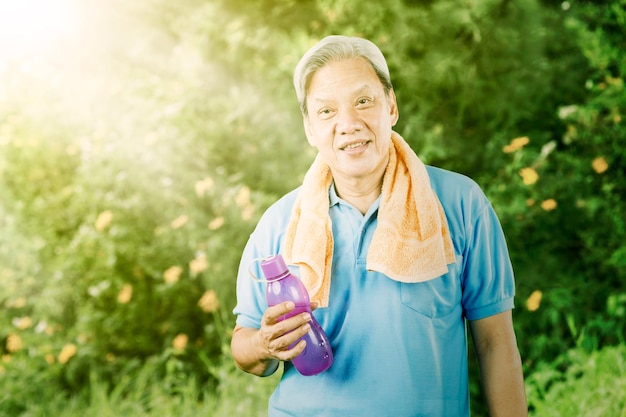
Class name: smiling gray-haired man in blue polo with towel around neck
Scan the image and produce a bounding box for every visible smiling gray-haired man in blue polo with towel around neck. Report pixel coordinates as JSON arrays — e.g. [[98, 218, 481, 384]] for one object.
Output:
[[231, 36, 527, 417]]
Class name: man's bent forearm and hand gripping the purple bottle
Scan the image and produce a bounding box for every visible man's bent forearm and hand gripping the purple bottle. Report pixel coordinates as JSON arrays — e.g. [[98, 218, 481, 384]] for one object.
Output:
[[230, 302, 311, 376]]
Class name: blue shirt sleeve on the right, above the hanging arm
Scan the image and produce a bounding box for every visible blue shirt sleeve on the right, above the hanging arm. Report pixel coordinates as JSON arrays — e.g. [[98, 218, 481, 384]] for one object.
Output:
[[462, 192, 515, 320]]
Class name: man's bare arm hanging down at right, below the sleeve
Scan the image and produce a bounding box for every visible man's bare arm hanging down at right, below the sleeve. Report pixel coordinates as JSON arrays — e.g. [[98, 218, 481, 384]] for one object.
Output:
[[470, 310, 528, 417]]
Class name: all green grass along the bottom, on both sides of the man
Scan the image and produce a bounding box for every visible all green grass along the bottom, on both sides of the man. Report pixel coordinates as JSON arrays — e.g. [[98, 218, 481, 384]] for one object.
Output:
[[0, 345, 626, 417]]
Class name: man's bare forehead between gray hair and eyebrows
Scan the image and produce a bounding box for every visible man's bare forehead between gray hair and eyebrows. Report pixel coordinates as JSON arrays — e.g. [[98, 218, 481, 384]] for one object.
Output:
[[307, 58, 383, 99]]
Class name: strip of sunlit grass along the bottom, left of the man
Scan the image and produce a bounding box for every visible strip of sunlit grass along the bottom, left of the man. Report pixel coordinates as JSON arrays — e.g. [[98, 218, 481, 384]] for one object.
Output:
[[0, 350, 279, 417]]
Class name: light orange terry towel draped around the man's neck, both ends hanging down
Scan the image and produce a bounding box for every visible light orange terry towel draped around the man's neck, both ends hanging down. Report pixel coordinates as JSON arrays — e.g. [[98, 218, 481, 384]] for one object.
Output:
[[283, 132, 455, 307]]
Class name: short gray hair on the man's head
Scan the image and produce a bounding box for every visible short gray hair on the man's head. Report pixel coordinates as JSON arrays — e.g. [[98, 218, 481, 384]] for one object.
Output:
[[293, 35, 393, 115]]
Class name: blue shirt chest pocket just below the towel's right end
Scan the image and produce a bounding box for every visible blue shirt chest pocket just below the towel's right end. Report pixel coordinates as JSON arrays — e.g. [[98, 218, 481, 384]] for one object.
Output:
[[400, 257, 462, 319]]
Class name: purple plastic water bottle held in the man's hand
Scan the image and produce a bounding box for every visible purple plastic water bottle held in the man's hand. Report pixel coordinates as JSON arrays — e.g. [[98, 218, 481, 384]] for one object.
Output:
[[261, 255, 333, 376]]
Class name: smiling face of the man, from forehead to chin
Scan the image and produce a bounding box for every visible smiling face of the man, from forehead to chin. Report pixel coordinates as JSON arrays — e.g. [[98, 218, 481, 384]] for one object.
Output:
[[304, 58, 398, 179]]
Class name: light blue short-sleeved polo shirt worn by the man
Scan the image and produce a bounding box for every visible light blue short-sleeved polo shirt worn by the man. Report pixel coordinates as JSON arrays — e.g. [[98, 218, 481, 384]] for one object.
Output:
[[234, 167, 515, 417]]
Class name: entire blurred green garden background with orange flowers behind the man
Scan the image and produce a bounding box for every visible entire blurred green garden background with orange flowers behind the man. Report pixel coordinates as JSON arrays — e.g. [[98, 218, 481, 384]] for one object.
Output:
[[0, 0, 626, 417]]
